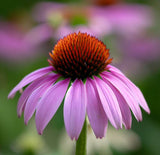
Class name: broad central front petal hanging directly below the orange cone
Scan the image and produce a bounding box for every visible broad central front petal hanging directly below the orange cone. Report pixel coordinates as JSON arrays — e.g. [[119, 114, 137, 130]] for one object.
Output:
[[63, 80, 86, 140]]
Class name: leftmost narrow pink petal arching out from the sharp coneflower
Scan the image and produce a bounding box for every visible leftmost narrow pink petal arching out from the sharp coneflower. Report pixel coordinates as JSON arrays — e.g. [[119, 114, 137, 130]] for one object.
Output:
[[8, 66, 54, 98]]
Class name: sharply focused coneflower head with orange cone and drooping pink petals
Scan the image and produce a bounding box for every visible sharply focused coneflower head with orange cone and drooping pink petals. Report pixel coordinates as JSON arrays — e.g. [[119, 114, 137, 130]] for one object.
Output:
[[8, 32, 150, 140]]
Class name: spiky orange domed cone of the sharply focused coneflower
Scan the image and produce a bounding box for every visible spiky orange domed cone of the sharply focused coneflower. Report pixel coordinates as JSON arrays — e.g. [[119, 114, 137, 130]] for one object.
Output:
[[49, 32, 112, 80]]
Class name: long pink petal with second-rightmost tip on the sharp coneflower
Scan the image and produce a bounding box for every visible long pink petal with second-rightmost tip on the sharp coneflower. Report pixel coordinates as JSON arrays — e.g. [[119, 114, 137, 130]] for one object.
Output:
[[103, 72, 142, 121]]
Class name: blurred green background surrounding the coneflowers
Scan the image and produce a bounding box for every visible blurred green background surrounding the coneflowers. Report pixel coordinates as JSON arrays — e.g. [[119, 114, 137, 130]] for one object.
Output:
[[0, 0, 160, 155]]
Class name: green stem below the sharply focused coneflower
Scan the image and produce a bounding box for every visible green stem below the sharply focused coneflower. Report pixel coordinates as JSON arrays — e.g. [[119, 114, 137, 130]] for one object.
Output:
[[76, 119, 87, 155]]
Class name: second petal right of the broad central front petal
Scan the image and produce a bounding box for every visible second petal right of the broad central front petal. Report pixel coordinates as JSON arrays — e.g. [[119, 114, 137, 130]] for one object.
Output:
[[94, 77, 122, 129]]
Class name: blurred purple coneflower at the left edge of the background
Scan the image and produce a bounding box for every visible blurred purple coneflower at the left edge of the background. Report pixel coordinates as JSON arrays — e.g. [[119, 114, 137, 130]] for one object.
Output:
[[0, 21, 52, 63]]
